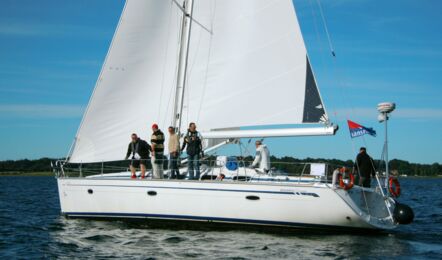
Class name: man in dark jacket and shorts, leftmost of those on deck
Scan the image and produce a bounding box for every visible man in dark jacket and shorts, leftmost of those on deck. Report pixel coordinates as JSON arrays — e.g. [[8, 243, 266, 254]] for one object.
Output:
[[126, 134, 151, 179]]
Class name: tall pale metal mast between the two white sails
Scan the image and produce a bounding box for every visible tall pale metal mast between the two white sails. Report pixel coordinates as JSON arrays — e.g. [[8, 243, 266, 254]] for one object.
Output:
[[172, 0, 193, 135]]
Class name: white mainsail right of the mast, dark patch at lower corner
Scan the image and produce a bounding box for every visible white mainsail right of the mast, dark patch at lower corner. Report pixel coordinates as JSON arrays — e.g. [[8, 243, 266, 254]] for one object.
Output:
[[183, 0, 325, 131]]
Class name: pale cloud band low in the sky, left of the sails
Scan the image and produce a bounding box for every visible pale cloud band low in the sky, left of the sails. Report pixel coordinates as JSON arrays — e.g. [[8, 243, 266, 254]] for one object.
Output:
[[0, 104, 85, 118]]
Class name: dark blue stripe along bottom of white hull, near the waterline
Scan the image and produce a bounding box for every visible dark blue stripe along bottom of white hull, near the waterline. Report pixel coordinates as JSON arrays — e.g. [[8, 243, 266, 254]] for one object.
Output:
[[63, 212, 374, 231]]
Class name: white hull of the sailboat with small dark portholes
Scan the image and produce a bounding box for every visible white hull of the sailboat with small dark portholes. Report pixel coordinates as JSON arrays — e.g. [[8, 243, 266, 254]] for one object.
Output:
[[58, 176, 395, 229]]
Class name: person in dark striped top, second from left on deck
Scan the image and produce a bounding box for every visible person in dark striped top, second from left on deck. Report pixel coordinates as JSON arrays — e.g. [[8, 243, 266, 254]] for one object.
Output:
[[150, 124, 165, 179]]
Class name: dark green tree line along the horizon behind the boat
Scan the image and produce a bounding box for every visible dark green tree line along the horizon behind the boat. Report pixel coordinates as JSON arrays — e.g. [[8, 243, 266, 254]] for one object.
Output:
[[0, 156, 442, 176]]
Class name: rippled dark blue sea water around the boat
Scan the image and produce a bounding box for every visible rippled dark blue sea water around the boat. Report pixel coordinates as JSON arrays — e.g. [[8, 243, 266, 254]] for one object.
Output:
[[0, 177, 442, 259]]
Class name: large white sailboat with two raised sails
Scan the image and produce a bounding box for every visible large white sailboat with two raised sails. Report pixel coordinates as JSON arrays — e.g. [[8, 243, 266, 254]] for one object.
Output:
[[56, 0, 414, 230]]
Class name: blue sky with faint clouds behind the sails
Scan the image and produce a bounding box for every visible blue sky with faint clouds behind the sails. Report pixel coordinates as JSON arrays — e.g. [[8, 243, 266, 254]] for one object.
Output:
[[0, 0, 442, 163]]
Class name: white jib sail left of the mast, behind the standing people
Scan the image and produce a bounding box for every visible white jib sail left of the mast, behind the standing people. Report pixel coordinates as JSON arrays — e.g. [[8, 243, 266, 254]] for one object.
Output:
[[69, 0, 181, 163]]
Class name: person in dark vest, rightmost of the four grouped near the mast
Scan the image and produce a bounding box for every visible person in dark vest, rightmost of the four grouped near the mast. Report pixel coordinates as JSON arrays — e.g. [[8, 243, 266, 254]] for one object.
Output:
[[181, 122, 204, 180]]
